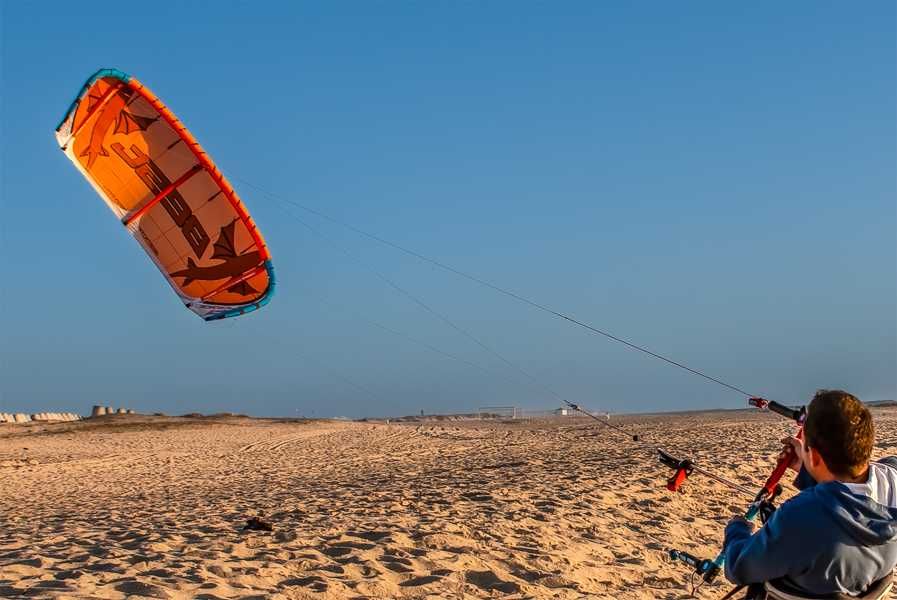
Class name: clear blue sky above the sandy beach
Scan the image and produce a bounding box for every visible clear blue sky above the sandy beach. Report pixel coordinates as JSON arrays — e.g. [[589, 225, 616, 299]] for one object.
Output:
[[0, 2, 897, 416]]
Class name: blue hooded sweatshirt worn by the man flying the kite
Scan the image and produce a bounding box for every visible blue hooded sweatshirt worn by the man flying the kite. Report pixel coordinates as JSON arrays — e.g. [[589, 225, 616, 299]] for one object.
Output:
[[724, 457, 897, 595]]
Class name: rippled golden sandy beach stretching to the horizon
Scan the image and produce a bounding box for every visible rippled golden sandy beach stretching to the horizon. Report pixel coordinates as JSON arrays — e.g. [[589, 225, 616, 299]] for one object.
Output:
[[0, 408, 897, 599]]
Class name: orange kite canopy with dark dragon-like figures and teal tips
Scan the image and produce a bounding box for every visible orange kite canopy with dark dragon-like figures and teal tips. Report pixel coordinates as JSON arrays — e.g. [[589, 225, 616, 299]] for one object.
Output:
[[56, 69, 274, 321]]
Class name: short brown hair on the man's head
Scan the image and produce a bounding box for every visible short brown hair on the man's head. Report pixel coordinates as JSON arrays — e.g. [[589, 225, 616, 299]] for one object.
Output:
[[804, 390, 875, 477]]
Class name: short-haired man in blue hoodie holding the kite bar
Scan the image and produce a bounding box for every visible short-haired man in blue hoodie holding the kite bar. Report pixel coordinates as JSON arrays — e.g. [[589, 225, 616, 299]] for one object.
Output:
[[724, 390, 897, 596]]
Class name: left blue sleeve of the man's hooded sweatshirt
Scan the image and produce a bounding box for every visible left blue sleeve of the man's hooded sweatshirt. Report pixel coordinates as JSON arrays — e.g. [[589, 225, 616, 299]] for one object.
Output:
[[723, 502, 812, 585]]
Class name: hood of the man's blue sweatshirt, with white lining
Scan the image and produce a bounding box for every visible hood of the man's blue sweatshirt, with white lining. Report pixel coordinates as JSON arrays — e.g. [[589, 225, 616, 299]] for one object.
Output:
[[813, 463, 897, 546]]
